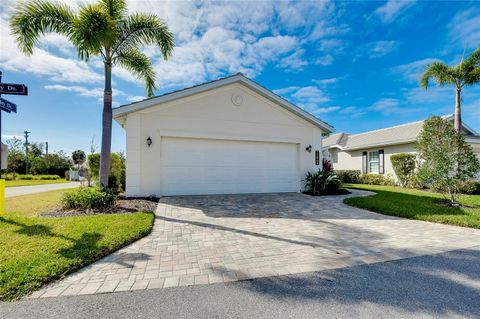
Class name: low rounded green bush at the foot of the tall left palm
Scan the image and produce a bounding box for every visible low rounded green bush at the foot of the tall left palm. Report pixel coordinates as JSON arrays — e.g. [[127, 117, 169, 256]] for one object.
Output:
[[62, 187, 117, 210]]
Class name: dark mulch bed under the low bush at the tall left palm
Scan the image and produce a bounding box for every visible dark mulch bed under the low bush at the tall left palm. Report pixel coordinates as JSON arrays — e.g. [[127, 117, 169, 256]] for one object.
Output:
[[40, 198, 158, 217]]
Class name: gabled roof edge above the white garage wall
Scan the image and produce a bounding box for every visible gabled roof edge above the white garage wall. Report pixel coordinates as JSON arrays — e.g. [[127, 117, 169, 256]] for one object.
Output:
[[113, 73, 335, 133]]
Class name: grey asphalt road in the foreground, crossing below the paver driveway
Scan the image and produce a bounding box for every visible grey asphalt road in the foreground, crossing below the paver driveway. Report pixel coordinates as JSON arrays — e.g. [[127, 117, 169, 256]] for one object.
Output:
[[0, 247, 480, 319]]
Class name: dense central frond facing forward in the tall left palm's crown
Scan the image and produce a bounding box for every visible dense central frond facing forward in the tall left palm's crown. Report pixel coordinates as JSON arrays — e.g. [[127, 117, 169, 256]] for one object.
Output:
[[73, 4, 115, 60]]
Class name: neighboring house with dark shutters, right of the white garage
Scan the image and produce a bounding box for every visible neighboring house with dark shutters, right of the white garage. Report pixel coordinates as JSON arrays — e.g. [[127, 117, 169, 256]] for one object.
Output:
[[323, 115, 480, 178]]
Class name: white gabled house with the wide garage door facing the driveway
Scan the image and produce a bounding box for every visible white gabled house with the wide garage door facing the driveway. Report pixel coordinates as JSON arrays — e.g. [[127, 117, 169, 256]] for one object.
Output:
[[113, 74, 333, 196]]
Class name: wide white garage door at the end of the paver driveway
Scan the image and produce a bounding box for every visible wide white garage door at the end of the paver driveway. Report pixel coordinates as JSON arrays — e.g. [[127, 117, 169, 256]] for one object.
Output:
[[160, 137, 300, 195]]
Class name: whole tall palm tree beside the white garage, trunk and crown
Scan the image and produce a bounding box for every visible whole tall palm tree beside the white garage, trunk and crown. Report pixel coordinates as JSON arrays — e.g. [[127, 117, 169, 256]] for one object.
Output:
[[10, 0, 174, 186]]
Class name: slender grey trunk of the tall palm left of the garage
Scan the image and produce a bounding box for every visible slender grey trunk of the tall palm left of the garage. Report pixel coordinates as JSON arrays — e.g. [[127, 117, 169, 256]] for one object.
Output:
[[100, 62, 112, 187]]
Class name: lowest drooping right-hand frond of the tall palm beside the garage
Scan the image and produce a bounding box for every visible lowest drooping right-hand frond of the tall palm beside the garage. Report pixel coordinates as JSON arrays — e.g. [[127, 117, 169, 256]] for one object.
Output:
[[113, 49, 156, 97]]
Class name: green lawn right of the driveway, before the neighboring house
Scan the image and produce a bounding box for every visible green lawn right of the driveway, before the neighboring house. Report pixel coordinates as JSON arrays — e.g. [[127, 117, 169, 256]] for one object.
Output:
[[344, 184, 480, 229]]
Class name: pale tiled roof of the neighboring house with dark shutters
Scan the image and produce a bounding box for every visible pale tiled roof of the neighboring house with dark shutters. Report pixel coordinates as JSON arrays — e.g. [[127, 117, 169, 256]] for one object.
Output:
[[323, 115, 478, 150]]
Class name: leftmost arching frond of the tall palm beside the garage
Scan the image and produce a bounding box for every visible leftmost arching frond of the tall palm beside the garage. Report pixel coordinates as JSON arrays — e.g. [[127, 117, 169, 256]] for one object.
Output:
[[10, 0, 76, 55]]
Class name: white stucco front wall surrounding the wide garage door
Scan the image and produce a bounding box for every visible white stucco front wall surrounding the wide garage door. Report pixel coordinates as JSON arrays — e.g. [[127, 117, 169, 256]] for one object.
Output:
[[125, 83, 322, 196]]
